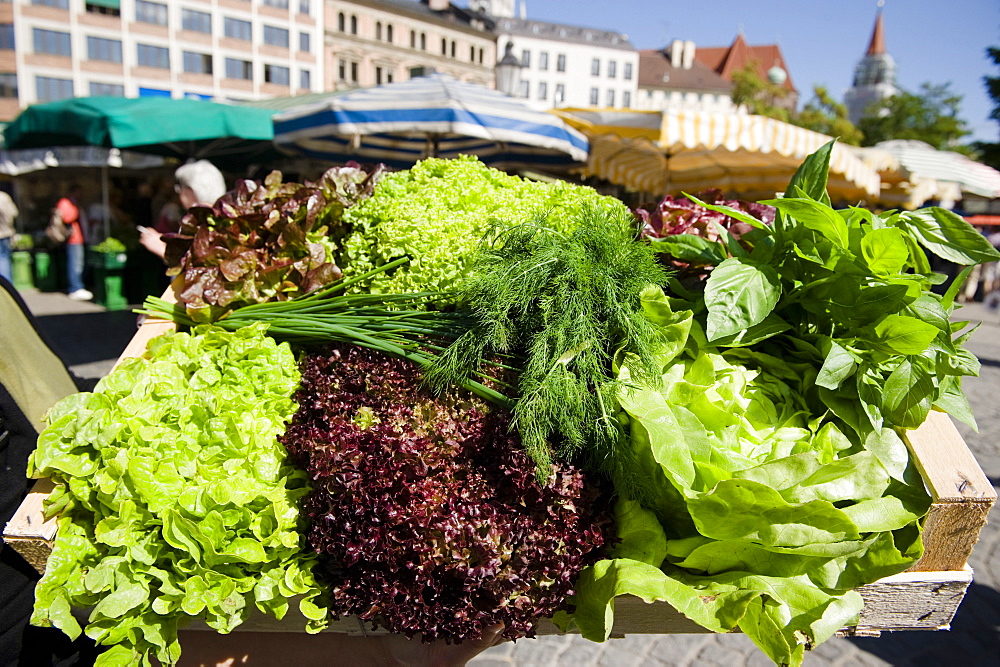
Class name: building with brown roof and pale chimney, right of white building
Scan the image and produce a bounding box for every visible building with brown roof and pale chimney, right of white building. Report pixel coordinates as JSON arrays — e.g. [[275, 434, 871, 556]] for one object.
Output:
[[635, 40, 735, 112]]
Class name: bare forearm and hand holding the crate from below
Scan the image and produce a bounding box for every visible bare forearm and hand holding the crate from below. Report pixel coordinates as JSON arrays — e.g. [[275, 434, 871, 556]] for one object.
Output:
[[178, 625, 504, 667]]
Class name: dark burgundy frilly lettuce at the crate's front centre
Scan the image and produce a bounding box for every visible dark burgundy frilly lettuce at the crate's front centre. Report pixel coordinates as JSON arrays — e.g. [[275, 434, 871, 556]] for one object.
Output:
[[280, 346, 605, 641]]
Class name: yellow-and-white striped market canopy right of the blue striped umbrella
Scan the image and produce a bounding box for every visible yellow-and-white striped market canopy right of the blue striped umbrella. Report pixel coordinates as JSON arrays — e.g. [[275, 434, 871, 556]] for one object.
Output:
[[552, 109, 880, 203]]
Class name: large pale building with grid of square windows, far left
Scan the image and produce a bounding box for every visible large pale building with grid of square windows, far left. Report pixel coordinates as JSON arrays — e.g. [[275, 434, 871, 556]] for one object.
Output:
[[0, 0, 324, 120]]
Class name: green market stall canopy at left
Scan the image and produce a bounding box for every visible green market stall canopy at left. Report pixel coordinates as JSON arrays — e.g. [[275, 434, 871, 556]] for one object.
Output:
[[4, 97, 274, 160]]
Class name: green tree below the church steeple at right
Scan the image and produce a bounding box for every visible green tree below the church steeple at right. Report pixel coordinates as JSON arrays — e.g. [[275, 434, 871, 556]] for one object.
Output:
[[858, 83, 969, 150]]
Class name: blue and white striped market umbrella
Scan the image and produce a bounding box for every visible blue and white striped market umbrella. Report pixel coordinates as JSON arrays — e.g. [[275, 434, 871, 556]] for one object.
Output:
[[274, 74, 588, 169]]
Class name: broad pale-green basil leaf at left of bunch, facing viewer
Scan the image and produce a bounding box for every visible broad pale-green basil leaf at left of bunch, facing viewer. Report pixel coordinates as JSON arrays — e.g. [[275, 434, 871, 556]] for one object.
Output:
[[705, 257, 781, 341]]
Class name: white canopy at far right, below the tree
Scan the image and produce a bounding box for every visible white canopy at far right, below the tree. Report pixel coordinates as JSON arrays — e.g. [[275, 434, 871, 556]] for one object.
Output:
[[875, 139, 1000, 201]]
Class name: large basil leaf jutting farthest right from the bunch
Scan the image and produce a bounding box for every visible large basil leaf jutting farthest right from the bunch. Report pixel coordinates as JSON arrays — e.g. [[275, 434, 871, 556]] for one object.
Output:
[[898, 206, 1000, 265]]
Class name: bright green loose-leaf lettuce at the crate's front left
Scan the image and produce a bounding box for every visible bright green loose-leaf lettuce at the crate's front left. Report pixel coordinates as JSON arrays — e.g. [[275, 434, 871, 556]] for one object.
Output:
[[29, 326, 327, 664]]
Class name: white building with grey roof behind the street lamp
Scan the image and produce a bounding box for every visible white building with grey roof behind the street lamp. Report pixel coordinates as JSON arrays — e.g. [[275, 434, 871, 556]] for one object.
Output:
[[486, 11, 639, 109]]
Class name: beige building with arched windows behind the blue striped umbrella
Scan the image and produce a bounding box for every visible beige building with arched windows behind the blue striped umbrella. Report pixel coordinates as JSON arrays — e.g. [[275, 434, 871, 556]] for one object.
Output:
[[324, 0, 497, 90]]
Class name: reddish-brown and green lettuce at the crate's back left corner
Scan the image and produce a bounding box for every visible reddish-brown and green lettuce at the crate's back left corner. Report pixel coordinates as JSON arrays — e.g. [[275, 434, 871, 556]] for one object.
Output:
[[164, 165, 381, 322]]
